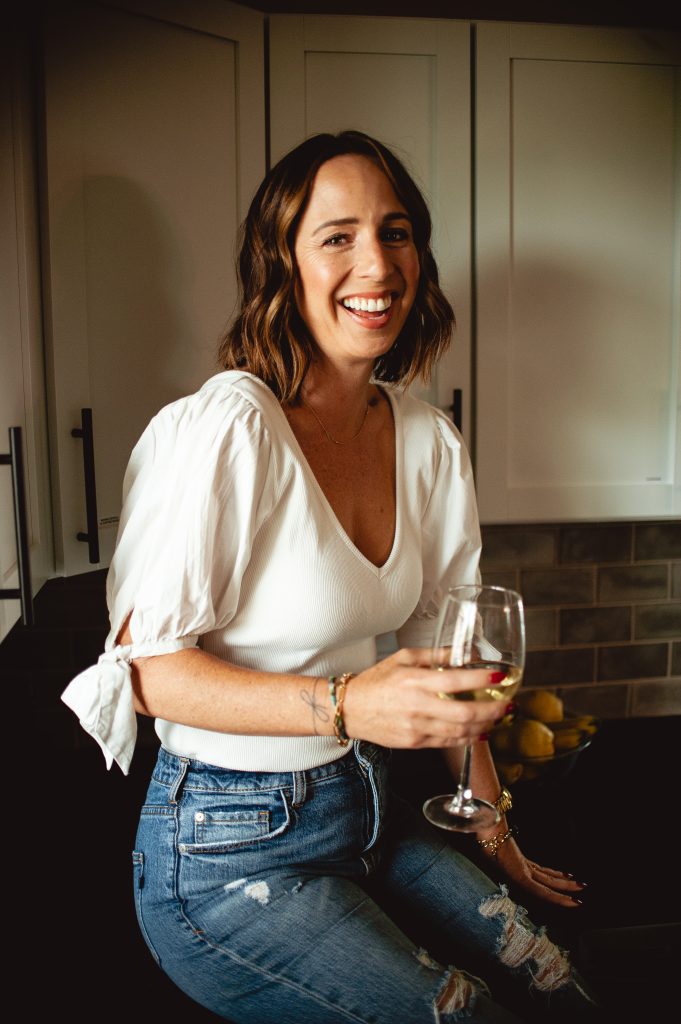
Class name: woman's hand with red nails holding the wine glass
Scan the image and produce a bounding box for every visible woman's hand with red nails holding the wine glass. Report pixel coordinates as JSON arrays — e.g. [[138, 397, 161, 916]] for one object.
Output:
[[343, 647, 506, 750]]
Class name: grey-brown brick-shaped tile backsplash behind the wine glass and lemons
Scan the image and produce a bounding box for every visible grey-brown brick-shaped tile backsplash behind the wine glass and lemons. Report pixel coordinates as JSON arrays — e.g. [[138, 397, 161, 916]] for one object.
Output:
[[482, 521, 681, 718]]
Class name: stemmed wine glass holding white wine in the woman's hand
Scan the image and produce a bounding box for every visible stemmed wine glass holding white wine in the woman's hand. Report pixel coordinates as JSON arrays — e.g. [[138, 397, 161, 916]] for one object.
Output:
[[423, 584, 525, 831]]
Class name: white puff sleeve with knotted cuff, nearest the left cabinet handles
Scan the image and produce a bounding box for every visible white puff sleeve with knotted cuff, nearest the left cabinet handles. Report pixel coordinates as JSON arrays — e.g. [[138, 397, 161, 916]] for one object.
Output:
[[62, 385, 275, 774]]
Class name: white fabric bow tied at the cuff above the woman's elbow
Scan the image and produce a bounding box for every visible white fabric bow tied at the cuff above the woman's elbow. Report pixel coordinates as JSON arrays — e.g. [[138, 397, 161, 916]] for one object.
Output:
[[61, 636, 197, 775]]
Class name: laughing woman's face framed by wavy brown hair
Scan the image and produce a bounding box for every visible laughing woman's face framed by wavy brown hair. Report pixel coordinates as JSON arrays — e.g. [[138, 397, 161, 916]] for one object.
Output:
[[295, 156, 419, 369]]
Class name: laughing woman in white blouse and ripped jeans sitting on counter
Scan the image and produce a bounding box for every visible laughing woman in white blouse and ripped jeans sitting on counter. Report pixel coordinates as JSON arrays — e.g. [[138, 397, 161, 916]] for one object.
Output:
[[65, 132, 591, 1024]]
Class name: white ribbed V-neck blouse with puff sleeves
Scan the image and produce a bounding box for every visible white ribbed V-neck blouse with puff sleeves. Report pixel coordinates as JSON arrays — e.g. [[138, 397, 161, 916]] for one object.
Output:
[[62, 371, 480, 774]]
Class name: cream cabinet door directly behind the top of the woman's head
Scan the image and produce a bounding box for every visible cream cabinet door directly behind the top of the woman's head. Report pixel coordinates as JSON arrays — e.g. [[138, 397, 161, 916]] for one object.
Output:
[[269, 15, 470, 433]]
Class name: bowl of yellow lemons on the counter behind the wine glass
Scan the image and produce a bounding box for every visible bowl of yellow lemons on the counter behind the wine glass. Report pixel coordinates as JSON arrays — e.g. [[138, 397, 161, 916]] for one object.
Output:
[[490, 689, 598, 785]]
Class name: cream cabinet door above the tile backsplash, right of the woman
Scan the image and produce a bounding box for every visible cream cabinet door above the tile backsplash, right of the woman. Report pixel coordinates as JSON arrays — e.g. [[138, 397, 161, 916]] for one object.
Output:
[[476, 24, 681, 522]]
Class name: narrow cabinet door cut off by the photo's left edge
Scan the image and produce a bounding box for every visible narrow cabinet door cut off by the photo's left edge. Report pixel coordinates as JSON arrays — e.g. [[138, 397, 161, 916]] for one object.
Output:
[[0, 27, 53, 640]]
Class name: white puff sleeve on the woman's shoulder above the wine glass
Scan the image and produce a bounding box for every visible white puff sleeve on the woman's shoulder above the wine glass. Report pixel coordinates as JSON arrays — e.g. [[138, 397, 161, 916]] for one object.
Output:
[[396, 409, 481, 647]]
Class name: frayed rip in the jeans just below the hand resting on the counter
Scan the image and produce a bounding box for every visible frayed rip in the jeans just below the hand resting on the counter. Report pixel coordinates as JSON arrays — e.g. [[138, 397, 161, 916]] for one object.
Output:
[[479, 891, 571, 992]]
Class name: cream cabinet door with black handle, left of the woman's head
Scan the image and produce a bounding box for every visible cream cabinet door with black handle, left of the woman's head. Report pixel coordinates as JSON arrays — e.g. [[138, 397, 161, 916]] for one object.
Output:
[[39, 0, 264, 573]]
